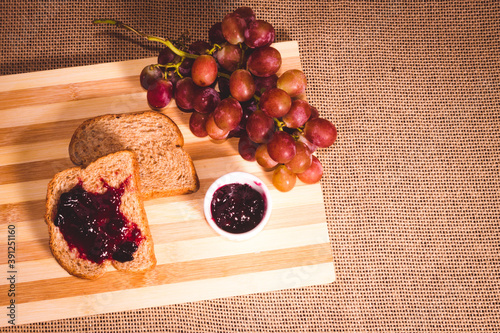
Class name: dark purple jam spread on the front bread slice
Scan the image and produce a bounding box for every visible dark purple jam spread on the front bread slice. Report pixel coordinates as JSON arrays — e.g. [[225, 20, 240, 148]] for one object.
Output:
[[54, 179, 143, 264]]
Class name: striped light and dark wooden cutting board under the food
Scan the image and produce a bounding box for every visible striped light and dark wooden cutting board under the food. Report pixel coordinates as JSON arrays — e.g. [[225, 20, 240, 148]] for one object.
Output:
[[0, 42, 335, 326]]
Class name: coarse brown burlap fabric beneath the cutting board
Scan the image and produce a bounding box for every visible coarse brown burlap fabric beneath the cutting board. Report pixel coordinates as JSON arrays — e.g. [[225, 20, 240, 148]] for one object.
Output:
[[0, 0, 500, 332]]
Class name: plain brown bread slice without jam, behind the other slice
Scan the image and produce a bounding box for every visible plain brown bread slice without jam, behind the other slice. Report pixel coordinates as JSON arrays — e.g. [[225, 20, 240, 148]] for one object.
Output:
[[69, 111, 200, 200]]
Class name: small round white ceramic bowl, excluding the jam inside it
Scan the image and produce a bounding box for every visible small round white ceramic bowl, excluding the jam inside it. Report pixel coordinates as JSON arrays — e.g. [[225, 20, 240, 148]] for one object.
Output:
[[204, 172, 272, 241]]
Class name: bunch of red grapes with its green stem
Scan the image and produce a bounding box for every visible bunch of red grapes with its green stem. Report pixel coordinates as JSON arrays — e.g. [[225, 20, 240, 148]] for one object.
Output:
[[94, 7, 337, 192]]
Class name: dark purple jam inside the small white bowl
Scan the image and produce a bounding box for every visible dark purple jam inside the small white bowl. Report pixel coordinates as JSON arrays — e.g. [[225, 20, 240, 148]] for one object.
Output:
[[210, 183, 266, 234]]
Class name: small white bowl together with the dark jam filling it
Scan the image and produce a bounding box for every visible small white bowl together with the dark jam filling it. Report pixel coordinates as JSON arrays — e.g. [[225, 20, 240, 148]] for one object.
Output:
[[204, 172, 272, 240]]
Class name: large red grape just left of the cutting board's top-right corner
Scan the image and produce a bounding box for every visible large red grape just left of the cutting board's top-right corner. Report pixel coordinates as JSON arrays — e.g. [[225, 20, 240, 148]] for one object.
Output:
[[247, 46, 281, 77]]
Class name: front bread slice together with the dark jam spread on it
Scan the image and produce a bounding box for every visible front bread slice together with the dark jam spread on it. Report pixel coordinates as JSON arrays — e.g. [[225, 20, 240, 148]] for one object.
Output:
[[45, 151, 156, 279]]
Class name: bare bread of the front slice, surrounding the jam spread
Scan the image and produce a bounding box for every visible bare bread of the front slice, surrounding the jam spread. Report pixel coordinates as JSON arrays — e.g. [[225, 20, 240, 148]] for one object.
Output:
[[45, 151, 156, 279]]
